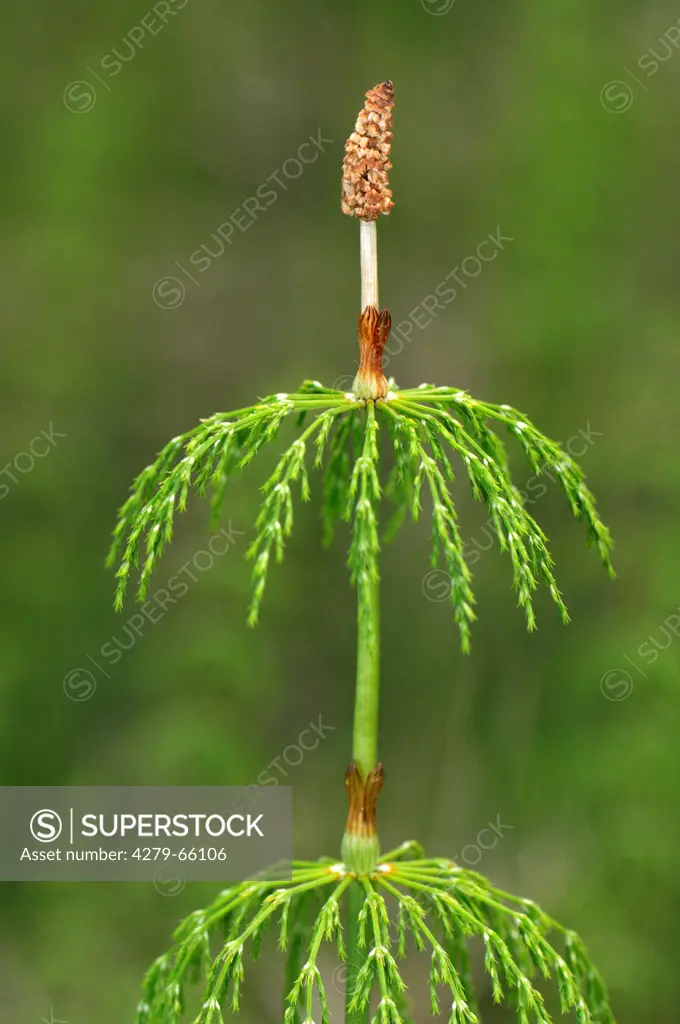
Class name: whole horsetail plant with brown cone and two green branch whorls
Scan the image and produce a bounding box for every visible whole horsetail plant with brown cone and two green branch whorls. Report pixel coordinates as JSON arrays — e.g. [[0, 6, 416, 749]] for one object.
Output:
[[110, 82, 613, 1024]]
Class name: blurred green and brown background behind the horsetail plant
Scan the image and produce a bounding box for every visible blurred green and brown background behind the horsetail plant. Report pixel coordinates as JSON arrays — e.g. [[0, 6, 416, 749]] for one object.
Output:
[[0, 0, 680, 1024]]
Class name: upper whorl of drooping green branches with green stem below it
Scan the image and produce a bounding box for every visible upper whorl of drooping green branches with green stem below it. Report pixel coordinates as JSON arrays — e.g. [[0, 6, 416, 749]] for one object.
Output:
[[109, 382, 612, 651]]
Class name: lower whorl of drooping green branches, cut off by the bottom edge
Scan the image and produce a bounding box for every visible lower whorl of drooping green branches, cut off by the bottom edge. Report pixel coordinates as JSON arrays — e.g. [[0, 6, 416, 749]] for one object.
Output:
[[137, 859, 613, 1024]]
